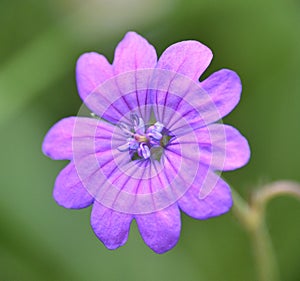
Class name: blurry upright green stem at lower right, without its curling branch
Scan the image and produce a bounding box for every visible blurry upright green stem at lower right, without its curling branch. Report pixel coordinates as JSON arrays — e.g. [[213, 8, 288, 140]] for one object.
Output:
[[232, 187, 279, 281]]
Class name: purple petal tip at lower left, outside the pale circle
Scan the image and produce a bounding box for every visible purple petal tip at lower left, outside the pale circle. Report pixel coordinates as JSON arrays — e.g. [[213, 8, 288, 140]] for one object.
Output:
[[53, 163, 94, 209]]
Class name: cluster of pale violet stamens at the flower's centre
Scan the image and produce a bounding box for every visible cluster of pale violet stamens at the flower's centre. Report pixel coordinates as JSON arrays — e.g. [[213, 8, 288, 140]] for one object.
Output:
[[118, 113, 170, 160]]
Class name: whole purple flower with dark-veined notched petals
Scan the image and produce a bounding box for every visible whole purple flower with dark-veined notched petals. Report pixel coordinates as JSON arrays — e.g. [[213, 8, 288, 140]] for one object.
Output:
[[43, 32, 250, 253]]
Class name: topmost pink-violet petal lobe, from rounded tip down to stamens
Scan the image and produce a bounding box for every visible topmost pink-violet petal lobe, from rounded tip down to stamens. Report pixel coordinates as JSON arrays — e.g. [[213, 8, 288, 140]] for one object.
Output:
[[106, 32, 157, 122]]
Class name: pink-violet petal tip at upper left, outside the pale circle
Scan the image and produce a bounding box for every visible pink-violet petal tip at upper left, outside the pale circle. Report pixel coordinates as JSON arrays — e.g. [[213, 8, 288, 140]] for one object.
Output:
[[76, 52, 113, 100]]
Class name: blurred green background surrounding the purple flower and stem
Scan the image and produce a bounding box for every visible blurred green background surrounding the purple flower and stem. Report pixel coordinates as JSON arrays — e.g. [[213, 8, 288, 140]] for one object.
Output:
[[0, 0, 300, 281]]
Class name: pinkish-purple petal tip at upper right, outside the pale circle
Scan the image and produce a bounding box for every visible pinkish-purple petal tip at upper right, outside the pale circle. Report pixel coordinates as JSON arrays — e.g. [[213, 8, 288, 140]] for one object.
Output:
[[200, 69, 242, 117]]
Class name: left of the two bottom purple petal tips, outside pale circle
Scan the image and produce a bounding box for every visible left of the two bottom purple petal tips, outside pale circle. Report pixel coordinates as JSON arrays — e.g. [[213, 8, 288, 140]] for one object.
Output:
[[91, 201, 132, 250]]
